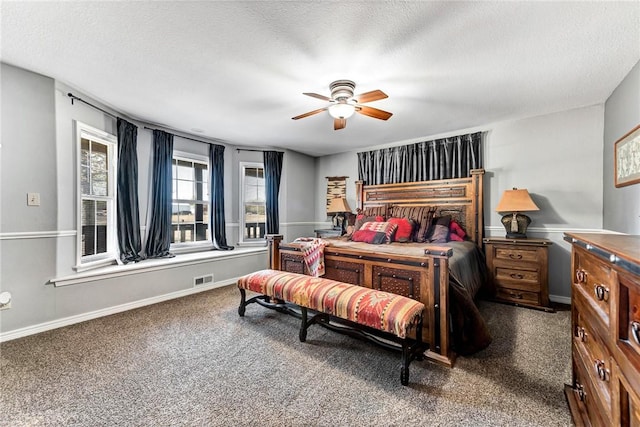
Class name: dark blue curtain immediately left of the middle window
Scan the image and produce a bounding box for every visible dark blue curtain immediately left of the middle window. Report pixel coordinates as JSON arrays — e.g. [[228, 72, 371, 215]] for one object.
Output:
[[146, 130, 173, 258]]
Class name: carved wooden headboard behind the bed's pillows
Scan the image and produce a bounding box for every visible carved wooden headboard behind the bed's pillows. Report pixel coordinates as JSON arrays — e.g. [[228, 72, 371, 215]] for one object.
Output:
[[356, 169, 484, 247]]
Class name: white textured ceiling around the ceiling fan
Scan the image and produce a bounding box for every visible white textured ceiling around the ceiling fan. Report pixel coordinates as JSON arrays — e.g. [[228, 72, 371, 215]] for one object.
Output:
[[0, 0, 640, 156]]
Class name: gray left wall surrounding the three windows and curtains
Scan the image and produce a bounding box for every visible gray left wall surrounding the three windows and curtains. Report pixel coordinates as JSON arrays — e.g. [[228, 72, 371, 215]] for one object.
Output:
[[0, 64, 284, 338]]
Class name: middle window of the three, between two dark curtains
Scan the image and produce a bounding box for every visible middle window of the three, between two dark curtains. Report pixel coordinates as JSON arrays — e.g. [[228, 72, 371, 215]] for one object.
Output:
[[171, 152, 211, 245]]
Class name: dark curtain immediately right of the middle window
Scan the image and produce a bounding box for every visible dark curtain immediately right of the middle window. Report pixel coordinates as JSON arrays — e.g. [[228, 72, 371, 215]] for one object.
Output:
[[209, 144, 233, 251]]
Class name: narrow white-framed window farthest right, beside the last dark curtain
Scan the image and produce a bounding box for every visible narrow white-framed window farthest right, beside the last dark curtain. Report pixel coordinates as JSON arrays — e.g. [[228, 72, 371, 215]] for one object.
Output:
[[240, 163, 267, 242]]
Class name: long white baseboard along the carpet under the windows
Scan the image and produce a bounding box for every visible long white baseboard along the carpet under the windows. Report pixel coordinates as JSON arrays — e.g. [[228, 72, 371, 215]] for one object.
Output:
[[0, 277, 238, 343]]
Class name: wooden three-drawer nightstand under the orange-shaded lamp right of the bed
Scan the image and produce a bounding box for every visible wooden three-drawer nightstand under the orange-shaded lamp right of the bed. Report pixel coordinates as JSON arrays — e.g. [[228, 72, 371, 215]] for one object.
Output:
[[482, 237, 554, 311]]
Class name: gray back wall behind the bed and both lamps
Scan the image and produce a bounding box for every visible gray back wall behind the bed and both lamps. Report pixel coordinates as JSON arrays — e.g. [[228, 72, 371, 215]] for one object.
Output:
[[315, 105, 603, 302]]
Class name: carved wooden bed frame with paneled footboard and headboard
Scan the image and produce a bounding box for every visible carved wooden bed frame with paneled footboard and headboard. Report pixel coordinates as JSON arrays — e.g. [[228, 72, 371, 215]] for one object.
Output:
[[267, 169, 490, 366]]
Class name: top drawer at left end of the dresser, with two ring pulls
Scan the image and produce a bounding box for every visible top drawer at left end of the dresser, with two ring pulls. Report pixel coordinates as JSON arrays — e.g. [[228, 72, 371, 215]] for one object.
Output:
[[573, 249, 613, 325]]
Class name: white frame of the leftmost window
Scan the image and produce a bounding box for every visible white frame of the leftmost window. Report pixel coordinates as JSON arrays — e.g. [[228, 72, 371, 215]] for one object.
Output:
[[75, 121, 119, 271]]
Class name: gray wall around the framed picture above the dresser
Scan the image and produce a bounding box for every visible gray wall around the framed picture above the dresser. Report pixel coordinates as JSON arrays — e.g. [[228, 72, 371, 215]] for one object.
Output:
[[602, 62, 640, 234]]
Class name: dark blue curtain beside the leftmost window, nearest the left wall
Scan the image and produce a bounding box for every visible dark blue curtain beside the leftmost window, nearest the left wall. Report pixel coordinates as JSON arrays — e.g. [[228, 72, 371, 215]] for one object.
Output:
[[117, 117, 143, 264]]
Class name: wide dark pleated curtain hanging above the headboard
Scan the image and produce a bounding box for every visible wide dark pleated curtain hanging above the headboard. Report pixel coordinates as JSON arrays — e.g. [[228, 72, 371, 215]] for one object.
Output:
[[358, 132, 483, 185]]
